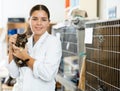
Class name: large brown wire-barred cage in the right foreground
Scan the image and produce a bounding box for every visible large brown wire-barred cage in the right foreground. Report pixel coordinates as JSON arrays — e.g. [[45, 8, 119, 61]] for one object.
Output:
[[85, 19, 120, 91]]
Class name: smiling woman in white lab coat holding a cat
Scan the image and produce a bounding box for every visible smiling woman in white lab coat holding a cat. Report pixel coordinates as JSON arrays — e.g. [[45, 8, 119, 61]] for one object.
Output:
[[9, 5, 62, 91]]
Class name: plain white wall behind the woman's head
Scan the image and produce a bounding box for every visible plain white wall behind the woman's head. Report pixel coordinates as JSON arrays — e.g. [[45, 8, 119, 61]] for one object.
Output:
[[0, 0, 65, 27]]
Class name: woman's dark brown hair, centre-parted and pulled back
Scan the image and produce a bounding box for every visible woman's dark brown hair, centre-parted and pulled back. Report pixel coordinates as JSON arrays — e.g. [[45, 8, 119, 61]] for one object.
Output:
[[30, 4, 50, 19]]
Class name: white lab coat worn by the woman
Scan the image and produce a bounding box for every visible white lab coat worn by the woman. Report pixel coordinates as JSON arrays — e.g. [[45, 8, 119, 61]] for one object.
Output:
[[8, 32, 62, 91]]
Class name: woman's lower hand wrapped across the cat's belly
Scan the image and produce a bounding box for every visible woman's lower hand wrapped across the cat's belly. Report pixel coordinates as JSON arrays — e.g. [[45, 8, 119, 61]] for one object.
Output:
[[13, 45, 29, 60]]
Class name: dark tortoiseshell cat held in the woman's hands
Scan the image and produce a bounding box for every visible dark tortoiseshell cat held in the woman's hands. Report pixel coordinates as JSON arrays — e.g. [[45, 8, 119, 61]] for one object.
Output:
[[14, 33, 28, 67]]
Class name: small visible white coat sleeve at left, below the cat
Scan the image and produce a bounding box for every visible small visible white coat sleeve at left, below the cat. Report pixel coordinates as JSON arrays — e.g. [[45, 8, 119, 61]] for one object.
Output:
[[8, 60, 19, 78]]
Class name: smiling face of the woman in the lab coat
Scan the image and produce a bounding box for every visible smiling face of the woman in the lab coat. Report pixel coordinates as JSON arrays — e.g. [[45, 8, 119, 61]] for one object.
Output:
[[29, 10, 49, 36]]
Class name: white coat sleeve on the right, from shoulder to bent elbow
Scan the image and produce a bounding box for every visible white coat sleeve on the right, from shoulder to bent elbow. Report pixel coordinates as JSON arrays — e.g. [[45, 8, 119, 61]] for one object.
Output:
[[33, 40, 62, 81]]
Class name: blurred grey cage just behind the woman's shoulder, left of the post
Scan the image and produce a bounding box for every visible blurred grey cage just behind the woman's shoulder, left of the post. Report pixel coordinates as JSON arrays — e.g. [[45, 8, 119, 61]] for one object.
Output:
[[52, 26, 78, 72]]
